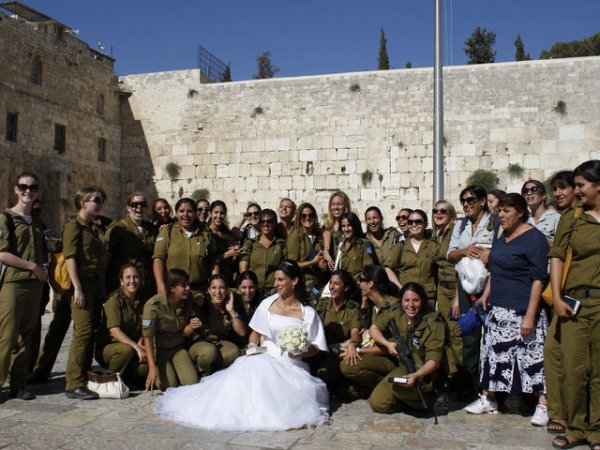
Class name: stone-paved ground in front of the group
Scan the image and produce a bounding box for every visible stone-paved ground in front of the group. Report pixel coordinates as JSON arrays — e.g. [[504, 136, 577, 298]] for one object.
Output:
[[0, 314, 552, 450]]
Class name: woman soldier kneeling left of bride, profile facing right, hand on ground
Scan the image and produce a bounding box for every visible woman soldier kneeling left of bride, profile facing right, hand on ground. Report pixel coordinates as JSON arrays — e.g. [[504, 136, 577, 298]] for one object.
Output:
[[142, 269, 201, 391]]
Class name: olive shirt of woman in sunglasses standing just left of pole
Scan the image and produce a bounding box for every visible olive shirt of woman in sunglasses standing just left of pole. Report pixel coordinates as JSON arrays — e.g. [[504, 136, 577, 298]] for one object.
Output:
[[388, 238, 438, 311]]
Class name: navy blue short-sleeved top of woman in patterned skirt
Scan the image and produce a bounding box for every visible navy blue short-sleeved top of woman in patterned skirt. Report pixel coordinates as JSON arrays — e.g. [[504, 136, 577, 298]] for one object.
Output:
[[488, 228, 548, 312]]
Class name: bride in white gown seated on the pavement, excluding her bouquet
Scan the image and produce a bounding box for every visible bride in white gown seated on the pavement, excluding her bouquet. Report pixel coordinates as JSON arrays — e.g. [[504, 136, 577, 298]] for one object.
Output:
[[154, 259, 329, 431]]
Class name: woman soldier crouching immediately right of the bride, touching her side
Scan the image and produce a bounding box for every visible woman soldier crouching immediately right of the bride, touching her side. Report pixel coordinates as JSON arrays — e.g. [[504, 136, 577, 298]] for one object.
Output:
[[316, 270, 361, 391]]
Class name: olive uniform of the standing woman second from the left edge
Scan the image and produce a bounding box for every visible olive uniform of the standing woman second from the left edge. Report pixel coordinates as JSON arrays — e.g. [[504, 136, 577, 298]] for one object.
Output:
[[62, 215, 106, 390]]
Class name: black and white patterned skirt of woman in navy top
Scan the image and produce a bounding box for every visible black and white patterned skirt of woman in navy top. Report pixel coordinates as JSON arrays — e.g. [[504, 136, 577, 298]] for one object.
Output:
[[481, 306, 548, 394]]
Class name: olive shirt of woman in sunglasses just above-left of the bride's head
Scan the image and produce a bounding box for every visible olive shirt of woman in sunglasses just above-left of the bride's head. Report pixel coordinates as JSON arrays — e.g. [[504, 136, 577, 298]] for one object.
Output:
[[241, 235, 286, 296]]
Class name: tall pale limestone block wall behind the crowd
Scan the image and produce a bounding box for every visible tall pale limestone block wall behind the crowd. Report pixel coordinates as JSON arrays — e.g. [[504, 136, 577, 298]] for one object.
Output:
[[122, 57, 600, 224]]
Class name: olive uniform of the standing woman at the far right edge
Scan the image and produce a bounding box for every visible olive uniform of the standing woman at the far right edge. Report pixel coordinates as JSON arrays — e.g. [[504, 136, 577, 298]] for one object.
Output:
[[549, 209, 600, 442]]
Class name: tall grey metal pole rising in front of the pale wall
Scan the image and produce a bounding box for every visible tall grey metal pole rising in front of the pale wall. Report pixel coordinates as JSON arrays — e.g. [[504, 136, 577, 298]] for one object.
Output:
[[433, 0, 444, 203]]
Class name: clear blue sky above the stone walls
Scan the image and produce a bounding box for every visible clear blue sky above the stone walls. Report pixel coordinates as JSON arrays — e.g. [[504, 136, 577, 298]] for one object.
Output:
[[10, 0, 600, 80]]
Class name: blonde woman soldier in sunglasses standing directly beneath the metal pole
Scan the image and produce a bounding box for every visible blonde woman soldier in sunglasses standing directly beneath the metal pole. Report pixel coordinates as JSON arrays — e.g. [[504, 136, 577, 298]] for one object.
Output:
[[432, 200, 456, 318]]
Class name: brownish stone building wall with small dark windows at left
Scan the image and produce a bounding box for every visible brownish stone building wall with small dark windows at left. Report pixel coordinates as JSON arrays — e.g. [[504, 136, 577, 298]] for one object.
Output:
[[0, 13, 123, 230]]
